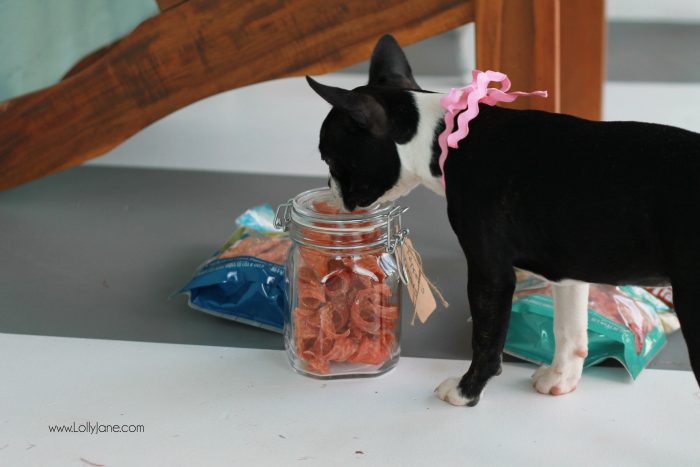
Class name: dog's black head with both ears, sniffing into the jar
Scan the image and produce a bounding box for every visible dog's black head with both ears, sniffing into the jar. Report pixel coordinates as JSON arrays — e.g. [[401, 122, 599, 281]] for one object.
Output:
[[307, 35, 420, 211]]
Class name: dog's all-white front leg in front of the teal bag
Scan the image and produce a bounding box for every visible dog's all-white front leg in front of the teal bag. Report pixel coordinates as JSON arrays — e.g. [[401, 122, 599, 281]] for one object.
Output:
[[532, 281, 589, 396]]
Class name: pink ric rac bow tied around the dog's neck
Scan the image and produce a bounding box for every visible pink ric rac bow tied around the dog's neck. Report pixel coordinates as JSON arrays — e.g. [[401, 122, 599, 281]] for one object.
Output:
[[438, 70, 547, 187]]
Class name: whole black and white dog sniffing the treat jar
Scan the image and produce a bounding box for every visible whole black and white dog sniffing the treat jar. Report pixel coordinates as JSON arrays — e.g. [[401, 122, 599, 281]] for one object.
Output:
[[307, 35, 700, 406]]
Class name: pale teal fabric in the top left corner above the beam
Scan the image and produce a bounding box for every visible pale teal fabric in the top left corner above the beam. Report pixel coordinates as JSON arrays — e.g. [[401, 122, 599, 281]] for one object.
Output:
[[0, 0, 159, 102]]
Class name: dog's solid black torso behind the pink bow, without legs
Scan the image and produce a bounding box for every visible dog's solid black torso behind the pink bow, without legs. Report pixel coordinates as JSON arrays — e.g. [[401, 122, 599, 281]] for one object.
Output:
[[445, 105, 700, 284]]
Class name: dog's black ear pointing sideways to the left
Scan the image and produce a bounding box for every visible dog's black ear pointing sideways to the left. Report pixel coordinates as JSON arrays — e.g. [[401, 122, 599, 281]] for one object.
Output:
[[306, 76, 387, 136]]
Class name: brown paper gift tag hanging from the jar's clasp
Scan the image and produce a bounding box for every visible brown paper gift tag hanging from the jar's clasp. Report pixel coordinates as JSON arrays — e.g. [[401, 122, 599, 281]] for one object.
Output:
[[396, 238, 450, 325]]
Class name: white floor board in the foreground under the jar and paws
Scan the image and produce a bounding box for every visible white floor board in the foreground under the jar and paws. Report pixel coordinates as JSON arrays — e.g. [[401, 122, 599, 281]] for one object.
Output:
[[0, 334, 700, 467]]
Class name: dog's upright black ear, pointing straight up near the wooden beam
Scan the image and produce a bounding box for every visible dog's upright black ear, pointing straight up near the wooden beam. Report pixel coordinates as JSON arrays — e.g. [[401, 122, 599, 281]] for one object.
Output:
[[369, 34, 420, 89]]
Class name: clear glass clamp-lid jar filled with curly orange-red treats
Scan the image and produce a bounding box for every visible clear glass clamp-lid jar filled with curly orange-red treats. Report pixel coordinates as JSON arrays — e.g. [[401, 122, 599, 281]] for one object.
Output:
[[275, 188, 408, 379]]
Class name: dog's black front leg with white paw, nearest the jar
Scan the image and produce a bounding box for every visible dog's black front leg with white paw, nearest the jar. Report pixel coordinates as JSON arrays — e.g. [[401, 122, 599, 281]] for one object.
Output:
[[435, 267, 515, 407]]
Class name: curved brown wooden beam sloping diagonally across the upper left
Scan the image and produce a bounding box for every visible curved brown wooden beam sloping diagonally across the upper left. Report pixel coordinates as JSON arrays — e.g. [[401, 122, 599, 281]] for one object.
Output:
[[0, 0, 474, 190]]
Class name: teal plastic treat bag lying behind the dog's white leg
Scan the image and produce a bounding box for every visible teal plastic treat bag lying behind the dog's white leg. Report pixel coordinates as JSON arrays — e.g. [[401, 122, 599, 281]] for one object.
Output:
[[505, 271, 672, 378]]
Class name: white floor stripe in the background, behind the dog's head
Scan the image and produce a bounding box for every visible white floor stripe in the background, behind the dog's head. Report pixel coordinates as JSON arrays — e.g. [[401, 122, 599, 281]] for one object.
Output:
[[90, 74, 700, 175]]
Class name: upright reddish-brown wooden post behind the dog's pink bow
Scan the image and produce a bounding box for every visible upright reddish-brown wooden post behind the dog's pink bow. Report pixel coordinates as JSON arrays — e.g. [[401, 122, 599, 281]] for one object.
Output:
[[476, 0, 605, 119]]
